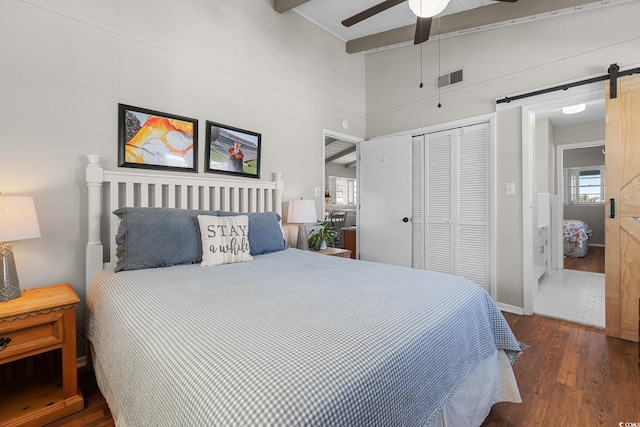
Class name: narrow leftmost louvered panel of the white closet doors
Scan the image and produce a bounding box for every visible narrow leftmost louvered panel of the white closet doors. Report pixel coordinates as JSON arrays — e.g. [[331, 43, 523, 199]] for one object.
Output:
[[411, 135, 425, 270]]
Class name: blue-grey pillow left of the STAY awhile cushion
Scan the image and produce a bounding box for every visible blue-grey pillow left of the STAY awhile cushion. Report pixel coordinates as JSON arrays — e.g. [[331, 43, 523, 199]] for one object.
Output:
[[113, 208, 217, 272]]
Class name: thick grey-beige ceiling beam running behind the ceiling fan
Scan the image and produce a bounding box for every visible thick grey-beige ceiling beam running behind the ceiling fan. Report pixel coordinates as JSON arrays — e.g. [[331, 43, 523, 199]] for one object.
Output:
[[346, 0, 593, 53]]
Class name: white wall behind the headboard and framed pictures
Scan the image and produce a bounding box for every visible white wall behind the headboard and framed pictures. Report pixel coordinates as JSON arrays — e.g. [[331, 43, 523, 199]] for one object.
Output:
[[0, 0, 365, 320]]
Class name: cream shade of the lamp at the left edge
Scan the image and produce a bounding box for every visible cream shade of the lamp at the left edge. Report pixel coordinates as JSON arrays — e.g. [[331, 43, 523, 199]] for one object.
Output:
[[0, 196, 40, 242]]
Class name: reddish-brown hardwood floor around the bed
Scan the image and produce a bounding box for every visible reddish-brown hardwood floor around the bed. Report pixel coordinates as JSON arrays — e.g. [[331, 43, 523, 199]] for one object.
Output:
[[50, 313, 640, 427]]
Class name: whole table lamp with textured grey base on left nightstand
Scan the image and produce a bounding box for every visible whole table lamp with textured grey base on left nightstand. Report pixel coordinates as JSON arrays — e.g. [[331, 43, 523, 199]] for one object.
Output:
[[0, 195, 40, 302]]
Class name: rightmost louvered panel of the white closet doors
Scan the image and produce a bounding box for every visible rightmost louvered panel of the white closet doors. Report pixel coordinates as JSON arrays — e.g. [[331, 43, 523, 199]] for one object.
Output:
[[454, 124, 489, 289]]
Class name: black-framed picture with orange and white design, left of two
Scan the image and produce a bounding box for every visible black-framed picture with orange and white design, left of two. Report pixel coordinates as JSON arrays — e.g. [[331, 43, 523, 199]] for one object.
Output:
[[118, 104, 198, 172]]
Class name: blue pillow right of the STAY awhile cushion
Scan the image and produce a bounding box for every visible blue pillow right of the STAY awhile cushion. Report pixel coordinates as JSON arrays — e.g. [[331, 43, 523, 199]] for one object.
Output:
[[217, 211, 287, 255]]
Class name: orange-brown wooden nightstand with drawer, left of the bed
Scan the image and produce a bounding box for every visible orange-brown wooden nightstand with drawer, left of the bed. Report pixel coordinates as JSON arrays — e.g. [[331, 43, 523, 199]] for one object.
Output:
[[0, 283, 84, 426]]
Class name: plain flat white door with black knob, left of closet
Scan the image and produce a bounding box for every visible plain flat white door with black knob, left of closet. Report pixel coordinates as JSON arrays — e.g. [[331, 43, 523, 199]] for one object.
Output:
[[357, 135, 411, 267]]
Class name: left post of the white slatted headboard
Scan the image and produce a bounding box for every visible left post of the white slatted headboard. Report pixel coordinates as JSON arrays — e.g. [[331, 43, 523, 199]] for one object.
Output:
[[85, 154, 104, 294]]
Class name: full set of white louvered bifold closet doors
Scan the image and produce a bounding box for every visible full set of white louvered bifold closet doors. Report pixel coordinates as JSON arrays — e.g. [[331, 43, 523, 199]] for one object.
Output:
[[412, 123, 491, 289]]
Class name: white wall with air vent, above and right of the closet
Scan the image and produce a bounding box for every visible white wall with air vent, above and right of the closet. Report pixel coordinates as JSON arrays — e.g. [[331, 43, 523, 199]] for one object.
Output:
[[366, 1, 640, 307]]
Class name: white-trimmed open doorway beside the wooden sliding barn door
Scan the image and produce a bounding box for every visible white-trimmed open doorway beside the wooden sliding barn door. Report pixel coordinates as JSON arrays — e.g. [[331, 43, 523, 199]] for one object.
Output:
[[522, 83, 605, 327]]
